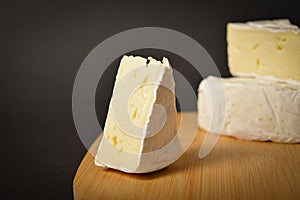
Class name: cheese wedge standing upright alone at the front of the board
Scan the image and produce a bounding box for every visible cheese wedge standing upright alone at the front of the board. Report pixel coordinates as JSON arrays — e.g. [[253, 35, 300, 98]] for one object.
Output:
[[95, 56, 180, 173]]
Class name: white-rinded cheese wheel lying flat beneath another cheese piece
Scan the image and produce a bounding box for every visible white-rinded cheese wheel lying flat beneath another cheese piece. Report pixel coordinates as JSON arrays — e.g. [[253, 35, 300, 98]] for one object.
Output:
[[198, 77, 300, 143]]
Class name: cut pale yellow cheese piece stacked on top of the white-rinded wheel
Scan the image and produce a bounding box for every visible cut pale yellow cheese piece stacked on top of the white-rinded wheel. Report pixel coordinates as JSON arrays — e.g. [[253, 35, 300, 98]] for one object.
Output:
[[227, 19, 300, 83]]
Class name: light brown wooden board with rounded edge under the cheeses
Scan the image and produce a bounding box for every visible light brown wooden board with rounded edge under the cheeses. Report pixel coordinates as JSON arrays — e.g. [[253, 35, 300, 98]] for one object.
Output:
[[73, 113, 300, 199]]
